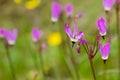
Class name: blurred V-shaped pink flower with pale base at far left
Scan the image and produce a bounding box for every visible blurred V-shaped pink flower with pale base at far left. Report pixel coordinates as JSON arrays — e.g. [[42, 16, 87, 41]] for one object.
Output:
[[4, 29, 18, 45]]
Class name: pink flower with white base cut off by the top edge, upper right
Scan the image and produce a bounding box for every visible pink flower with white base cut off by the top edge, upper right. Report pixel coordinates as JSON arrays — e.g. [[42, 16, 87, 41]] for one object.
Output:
[[102, 0, 115, 11]]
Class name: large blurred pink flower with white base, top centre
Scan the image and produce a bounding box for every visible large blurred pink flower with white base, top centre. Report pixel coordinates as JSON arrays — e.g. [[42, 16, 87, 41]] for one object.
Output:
[[51, 1, 62, 22]]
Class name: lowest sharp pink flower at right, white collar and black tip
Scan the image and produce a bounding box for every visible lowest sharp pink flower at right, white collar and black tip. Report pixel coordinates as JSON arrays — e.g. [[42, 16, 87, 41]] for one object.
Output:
[[100, 43, 110, 63]]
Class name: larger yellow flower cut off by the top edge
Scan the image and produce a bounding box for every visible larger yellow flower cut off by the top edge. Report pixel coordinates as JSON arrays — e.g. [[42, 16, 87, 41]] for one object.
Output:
[[25, 0, 41, 10]]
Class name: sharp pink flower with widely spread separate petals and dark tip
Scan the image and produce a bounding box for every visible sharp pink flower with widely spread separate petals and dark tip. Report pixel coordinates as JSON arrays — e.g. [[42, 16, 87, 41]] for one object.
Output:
[[65, 20, 84, 47]]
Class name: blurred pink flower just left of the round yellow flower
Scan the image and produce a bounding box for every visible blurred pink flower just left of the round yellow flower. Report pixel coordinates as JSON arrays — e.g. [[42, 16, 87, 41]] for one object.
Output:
[[32, 28, 42, 42]]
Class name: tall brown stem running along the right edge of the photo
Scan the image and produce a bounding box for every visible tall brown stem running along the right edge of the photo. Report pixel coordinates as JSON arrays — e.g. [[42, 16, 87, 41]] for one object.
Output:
[[116, 0, 120, 79]]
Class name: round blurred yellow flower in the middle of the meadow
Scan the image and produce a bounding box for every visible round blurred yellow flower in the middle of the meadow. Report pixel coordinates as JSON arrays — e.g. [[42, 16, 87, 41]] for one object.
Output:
[[48, 32, 62, 46]]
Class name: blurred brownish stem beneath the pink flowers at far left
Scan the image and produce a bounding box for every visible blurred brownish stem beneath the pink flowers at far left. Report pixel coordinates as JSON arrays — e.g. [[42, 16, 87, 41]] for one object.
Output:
[[4, 40, 16, 80]]
